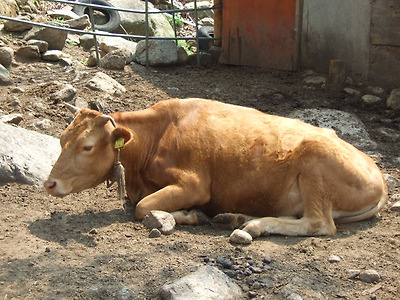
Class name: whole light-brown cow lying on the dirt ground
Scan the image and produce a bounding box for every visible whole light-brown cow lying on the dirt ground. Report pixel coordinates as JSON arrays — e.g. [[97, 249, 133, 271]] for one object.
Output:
[[44, 99, 388, 241]]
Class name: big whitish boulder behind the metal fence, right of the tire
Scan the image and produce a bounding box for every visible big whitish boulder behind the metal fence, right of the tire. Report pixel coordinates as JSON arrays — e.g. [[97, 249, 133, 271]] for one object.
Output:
[[109, 0, 174, 37]]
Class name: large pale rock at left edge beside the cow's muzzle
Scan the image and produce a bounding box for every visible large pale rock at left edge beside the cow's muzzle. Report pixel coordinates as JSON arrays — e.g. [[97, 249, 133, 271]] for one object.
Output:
[[0, 122, 61, 186]]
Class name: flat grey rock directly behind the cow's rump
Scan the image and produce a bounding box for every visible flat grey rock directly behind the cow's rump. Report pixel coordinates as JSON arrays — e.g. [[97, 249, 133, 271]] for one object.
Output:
[[289, 108, 377, 151]]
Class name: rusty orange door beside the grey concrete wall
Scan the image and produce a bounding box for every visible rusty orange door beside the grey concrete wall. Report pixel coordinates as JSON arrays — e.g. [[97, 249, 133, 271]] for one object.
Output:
[[220, 0, 297, 70]]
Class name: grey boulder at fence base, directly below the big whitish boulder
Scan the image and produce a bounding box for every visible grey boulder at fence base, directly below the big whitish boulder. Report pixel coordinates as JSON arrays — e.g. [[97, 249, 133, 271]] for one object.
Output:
[[135, 40, 179, 67]]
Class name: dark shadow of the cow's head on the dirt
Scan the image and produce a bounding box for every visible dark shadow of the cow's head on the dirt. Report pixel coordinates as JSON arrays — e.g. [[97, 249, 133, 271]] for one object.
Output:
[[28, 209, 134, 247]]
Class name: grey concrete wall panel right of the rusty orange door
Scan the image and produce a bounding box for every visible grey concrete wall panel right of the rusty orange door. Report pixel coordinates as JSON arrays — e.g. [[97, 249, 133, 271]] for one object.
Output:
[[300, 0, 371, 80]]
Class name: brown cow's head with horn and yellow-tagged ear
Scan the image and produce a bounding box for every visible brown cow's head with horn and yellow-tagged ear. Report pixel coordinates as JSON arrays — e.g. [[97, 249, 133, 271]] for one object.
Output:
[[44, 106, 132, 197]]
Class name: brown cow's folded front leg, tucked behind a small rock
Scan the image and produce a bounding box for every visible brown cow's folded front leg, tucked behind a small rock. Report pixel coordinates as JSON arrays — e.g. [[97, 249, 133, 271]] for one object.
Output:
[[135, 185, 210, 224]]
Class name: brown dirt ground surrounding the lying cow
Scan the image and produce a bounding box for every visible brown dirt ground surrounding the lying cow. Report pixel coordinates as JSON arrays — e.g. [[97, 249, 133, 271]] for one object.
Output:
[[0, 31, 400, 299]]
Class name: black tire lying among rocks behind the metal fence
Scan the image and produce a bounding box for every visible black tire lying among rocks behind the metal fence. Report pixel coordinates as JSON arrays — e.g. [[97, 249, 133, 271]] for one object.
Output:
[[72, 0, 121, 32]]
